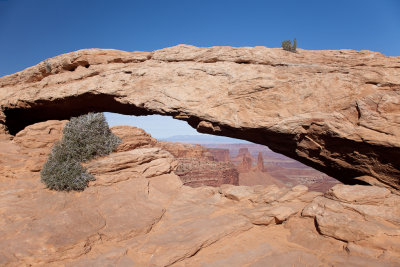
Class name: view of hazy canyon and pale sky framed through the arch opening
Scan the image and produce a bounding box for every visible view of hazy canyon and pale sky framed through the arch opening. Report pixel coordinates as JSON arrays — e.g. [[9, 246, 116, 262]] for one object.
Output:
[[105, 113, 340, 192]]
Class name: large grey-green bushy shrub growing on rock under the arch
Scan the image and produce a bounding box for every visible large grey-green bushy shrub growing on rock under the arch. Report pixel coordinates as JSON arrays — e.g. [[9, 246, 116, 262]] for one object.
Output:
[[40, 113, 121, 191]]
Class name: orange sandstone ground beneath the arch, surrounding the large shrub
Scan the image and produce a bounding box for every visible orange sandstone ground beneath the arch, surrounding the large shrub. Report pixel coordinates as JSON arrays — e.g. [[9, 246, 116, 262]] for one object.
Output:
[[0, 121, 400, 266]]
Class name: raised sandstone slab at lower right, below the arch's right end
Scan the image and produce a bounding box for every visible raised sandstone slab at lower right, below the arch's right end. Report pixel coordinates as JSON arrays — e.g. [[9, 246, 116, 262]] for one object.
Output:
[[302, 185, 400, 259]]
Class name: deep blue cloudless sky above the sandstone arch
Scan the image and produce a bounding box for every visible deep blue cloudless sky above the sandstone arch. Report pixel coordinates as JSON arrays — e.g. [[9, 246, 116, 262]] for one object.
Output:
[[0, 0, 400, 138]]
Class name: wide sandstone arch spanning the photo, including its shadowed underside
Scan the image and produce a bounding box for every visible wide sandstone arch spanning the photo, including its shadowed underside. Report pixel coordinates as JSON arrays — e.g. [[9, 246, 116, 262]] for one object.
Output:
[[0, 45, 400, 190]]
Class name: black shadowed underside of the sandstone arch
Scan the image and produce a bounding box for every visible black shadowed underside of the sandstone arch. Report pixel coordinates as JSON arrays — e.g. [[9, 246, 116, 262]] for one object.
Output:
[[2, 92, 394, 187]]
